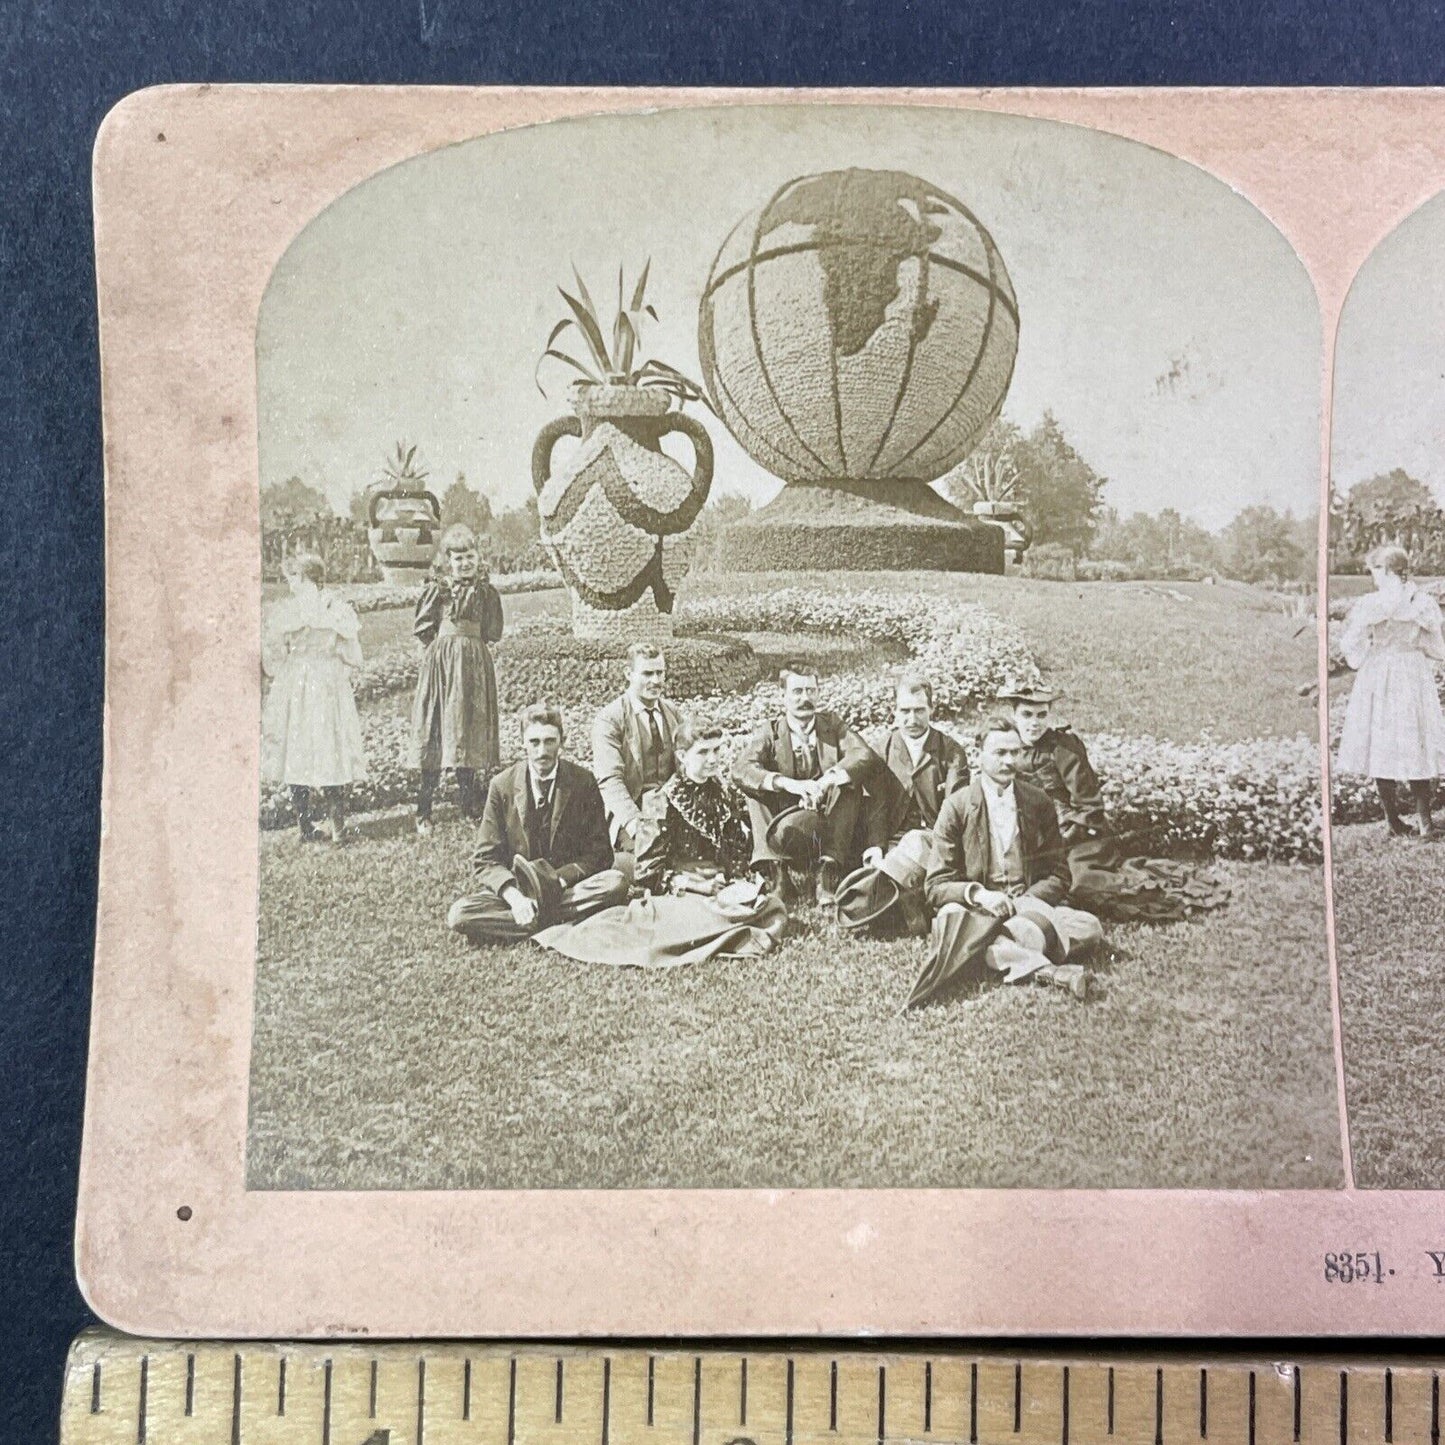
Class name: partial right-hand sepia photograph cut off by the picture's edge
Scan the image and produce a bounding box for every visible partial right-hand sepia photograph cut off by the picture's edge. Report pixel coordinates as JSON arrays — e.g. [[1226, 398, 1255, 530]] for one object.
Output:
[[1329, 186, 1445, 1189]]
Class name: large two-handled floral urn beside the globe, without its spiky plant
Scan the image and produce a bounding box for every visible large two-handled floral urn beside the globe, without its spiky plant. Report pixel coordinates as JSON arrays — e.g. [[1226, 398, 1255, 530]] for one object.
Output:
[[532, 381, 712, 642]]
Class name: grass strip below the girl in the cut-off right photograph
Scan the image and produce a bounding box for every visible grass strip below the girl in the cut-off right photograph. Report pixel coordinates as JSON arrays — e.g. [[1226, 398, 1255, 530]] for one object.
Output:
[[1334, 822, 1445, 1189]]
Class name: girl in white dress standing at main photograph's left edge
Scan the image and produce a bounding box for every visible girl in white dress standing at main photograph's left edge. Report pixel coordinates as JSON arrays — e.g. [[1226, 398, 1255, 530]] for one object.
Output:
[[262, 552, 366, 842]]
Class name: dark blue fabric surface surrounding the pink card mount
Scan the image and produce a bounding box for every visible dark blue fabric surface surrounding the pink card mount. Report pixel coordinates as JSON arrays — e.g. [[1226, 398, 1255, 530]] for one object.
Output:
[[0, 0, 1445, 1441]]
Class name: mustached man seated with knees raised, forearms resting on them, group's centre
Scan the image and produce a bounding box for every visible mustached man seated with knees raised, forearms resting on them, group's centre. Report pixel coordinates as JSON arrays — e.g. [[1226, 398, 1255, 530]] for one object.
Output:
[[733, 670, 881, 906]]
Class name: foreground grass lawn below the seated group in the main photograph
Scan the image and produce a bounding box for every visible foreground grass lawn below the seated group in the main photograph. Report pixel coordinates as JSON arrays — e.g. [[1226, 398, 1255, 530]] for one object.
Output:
[[247, 818, 1340, 1189]]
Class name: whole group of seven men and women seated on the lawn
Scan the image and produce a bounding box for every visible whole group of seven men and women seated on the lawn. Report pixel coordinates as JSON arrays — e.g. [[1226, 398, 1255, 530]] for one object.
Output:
[[448, 643, 1138, 1003]]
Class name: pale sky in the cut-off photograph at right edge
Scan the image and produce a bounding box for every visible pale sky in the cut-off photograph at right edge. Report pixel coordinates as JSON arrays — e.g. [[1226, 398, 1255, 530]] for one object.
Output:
[[1331, 186, 1445, 506]]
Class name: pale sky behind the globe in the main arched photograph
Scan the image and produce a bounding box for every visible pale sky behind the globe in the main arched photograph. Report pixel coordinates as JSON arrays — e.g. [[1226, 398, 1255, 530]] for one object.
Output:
[[257, 105, 1321, 527]]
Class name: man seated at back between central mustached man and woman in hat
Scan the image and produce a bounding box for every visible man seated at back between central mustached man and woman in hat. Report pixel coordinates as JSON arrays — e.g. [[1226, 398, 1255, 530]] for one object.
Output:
[[863, 672, 968, 866]]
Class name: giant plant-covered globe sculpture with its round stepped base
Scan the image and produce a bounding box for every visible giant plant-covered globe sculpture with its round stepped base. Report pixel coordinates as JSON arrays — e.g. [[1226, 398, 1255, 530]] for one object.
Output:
[[698, 169, 1019, 572]]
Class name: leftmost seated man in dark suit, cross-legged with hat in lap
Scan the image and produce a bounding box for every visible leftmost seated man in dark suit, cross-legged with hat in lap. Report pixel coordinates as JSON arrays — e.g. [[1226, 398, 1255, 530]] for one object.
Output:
[[447, 702, 627, 944]]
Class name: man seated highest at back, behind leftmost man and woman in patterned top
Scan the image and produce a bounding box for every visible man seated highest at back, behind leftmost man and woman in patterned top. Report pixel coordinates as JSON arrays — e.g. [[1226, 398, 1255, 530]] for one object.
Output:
[[592, 642, 679, 861]]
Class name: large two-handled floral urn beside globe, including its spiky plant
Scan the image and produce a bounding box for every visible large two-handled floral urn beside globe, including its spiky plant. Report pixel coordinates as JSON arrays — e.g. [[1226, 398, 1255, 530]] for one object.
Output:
[[532, 264, 712, 640]]
